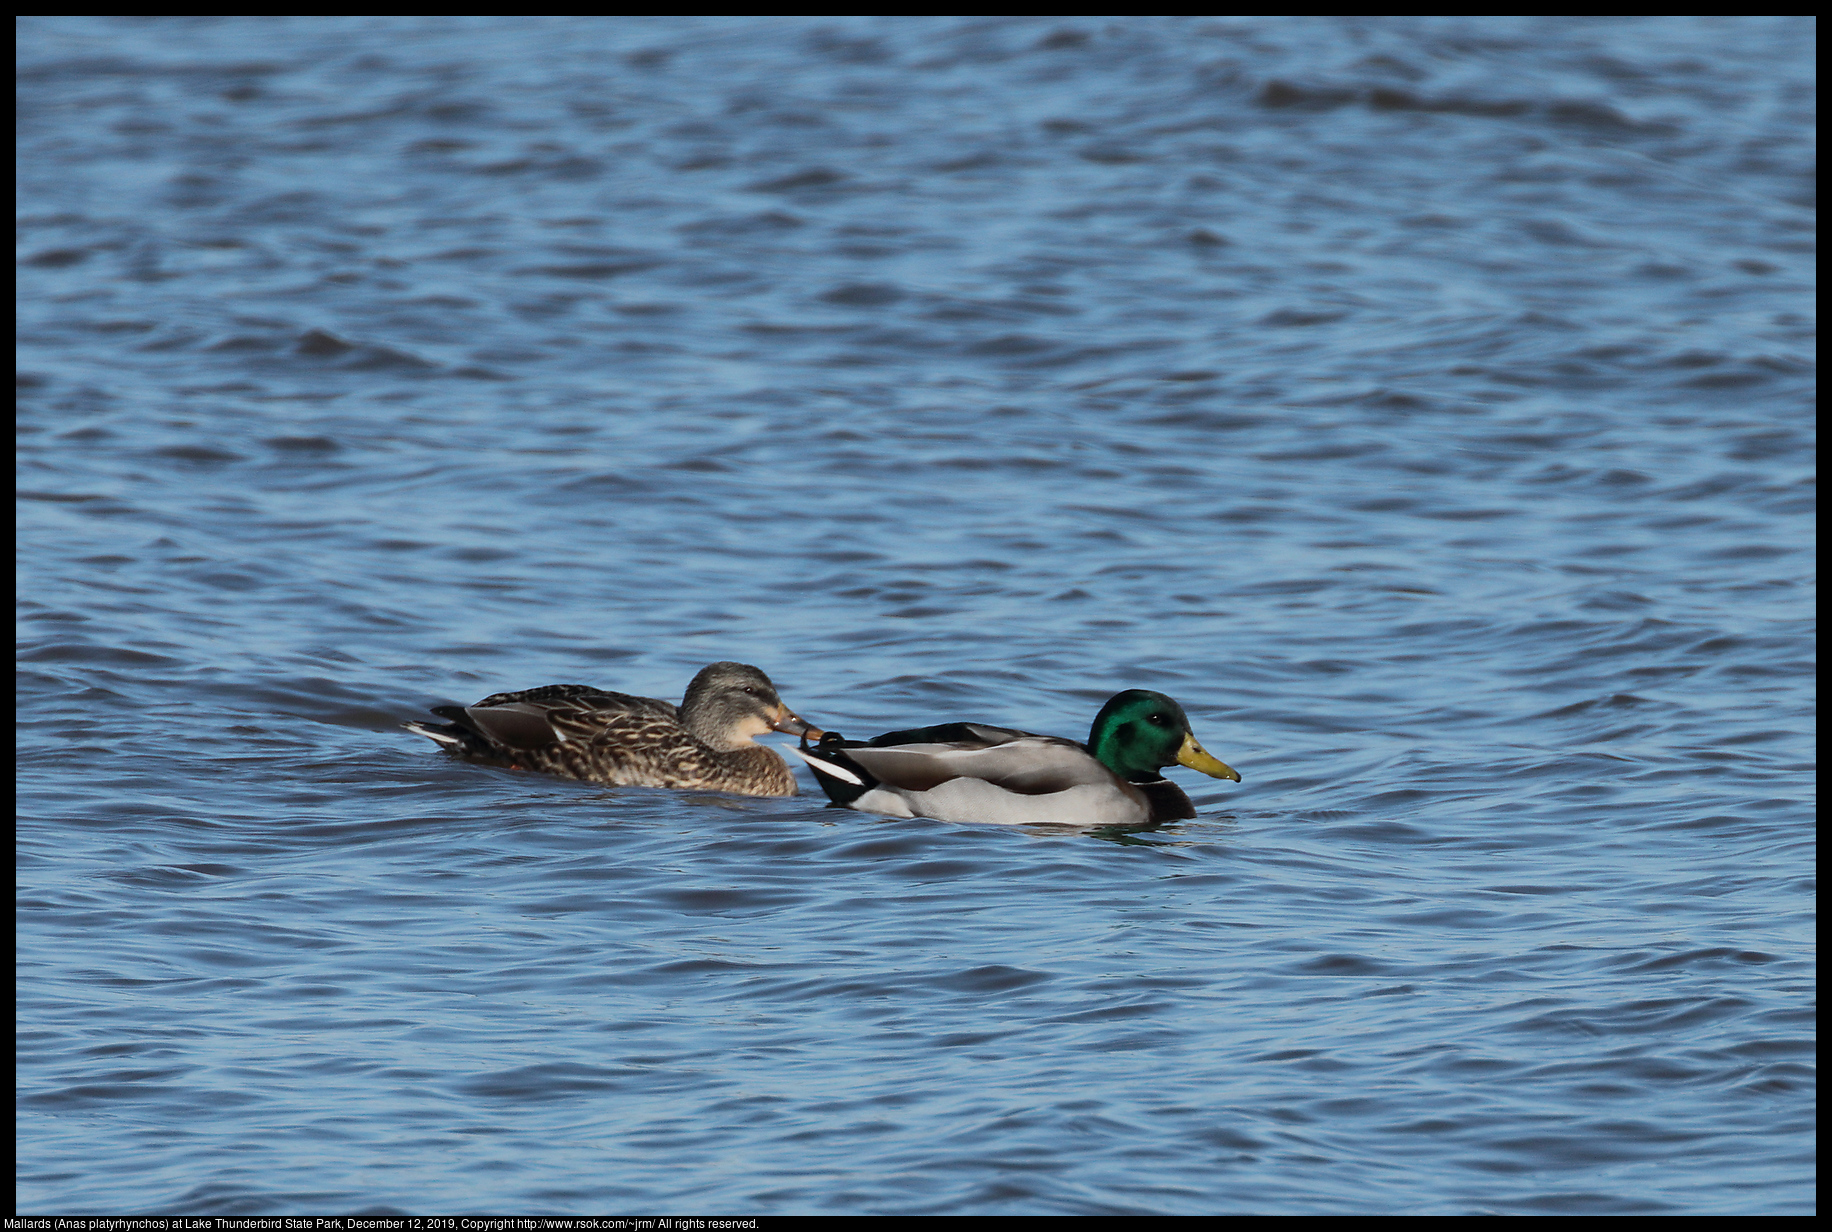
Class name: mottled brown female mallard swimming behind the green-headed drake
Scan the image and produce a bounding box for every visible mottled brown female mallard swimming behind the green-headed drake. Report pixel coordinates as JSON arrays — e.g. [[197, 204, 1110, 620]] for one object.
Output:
[[412, 664, 823, 796]]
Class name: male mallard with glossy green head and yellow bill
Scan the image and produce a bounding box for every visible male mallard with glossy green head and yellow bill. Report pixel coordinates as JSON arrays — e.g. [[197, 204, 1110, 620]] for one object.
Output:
[[793, 689, 1240, 825]]
